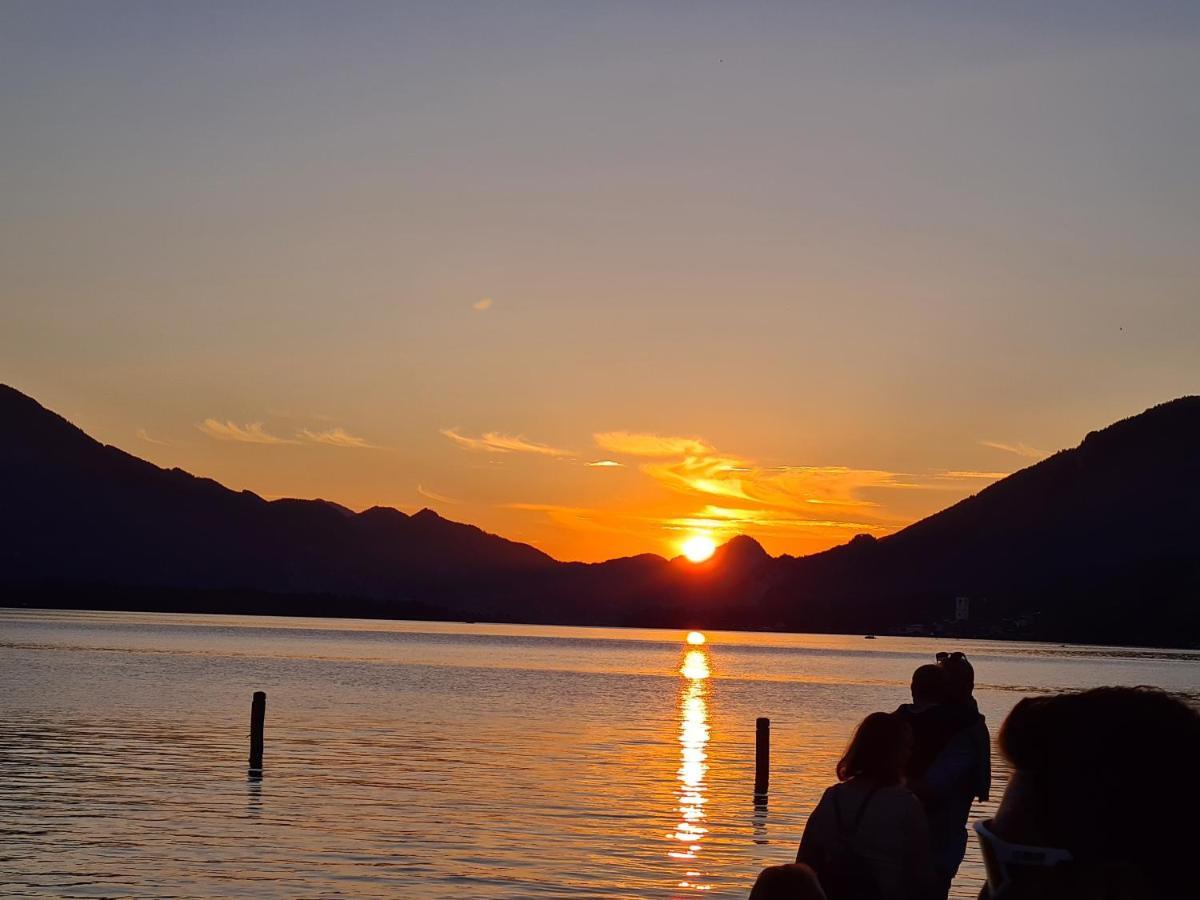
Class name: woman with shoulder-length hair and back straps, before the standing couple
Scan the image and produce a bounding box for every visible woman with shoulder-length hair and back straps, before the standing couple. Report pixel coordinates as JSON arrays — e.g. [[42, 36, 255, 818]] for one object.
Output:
[[796, 713, 932, 900]]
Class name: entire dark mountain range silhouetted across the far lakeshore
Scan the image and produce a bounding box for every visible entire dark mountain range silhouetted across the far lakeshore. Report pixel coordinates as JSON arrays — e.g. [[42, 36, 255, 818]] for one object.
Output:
[[0, 385, 1200, 646]]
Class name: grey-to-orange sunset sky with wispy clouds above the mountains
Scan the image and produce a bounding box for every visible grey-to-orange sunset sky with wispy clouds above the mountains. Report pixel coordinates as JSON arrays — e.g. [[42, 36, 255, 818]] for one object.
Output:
[[0, 0, 1200, 560]]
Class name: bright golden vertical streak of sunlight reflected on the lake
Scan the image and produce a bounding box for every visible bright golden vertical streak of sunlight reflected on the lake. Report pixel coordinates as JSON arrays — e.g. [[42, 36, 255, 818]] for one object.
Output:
[[667, 649, 713, 890]]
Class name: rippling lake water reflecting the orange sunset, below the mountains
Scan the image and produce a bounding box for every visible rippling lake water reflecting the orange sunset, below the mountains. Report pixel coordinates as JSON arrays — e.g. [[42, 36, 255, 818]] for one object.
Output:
[[0, 610, 1200, 898]]
